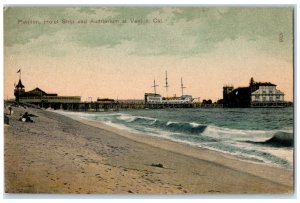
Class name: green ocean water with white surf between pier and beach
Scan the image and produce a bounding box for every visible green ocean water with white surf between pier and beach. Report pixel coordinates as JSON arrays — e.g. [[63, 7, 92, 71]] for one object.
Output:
[[56, 108, 294, 168]]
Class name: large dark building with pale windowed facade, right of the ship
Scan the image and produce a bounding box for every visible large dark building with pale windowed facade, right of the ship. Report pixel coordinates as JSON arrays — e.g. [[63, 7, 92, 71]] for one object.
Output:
[[223, 78, 285, 108]]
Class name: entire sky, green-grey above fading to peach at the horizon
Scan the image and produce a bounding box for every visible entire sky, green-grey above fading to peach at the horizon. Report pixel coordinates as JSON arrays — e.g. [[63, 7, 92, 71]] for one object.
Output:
[[4, 6, 293, 101]]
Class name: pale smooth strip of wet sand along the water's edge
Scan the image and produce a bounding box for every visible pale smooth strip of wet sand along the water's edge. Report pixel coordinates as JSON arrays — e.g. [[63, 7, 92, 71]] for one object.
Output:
[[59, 111, 294, 186]]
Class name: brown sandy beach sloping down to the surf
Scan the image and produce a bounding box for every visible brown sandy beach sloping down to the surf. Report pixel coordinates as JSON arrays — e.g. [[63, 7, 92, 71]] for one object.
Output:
[[4, 108, 294, 194]]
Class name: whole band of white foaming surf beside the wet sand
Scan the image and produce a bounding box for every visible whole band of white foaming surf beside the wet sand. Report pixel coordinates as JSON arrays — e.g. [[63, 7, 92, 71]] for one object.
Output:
[[53, 109, 294, 167]]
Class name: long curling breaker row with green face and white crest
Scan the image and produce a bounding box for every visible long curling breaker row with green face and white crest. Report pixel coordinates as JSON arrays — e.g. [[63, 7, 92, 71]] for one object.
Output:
[[113, 114, 294, 147]]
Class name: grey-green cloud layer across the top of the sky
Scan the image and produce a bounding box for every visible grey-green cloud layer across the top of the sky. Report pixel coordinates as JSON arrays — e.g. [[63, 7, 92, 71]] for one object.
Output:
[[4, 7, 293, 60]]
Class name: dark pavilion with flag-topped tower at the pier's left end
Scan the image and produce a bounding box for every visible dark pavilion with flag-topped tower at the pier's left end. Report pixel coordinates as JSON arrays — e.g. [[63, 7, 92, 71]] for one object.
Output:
[[14, 79, 81, 104]]
